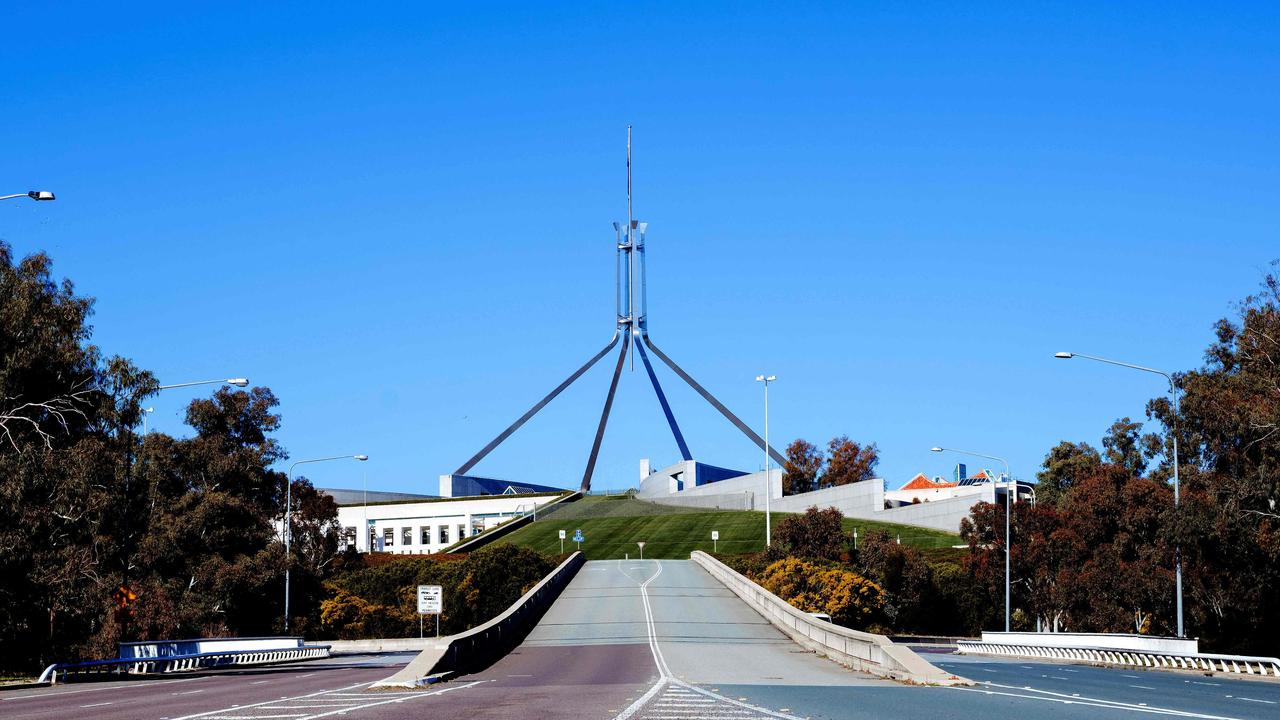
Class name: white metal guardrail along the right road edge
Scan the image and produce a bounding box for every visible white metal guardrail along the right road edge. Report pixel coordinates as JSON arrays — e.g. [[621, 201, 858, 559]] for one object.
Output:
[[956, 641, 1280, 678]]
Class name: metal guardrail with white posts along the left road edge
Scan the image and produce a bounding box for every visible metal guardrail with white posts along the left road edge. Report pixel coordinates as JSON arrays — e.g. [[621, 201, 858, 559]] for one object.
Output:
[[38, 644, 329, 684]]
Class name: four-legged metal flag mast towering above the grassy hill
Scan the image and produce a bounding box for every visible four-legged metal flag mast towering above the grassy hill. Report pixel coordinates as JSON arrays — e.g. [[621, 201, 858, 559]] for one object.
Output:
[[453, 126, 786, 492]]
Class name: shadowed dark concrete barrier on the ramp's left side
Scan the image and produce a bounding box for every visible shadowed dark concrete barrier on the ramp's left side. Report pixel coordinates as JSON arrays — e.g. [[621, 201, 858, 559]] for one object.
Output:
[[372, 552, 586, 688]]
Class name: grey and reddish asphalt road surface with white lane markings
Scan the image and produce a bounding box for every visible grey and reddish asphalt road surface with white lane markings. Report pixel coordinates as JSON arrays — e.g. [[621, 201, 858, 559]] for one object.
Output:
[[0, 560, 1280, 720]]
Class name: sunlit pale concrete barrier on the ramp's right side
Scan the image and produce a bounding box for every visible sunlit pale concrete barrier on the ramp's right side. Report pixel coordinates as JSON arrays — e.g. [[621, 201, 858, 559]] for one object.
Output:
[[690, 550, 973, 685]]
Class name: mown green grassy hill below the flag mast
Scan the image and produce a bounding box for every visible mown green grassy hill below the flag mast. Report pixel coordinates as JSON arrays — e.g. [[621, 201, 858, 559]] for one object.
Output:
[[497, 497, 960, 560]]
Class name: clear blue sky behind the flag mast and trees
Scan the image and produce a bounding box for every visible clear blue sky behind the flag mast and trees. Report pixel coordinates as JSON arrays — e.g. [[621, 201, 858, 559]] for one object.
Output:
[[0, 3, 1280, 492]]
